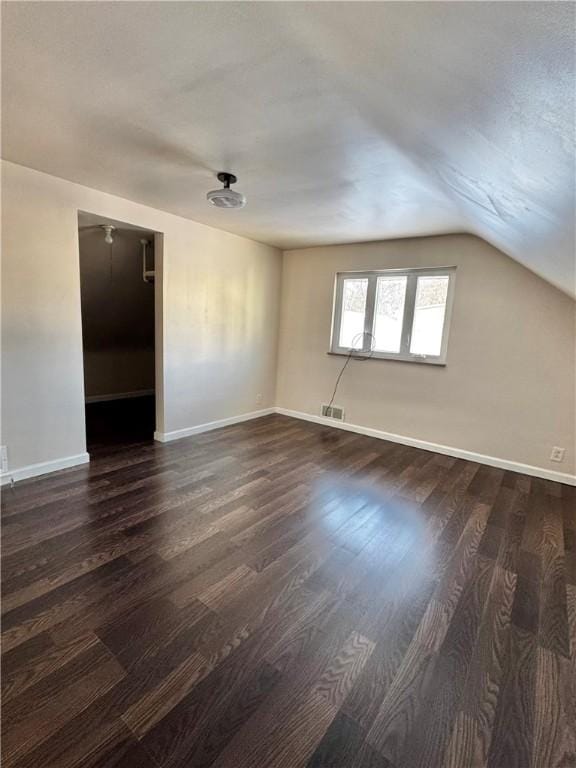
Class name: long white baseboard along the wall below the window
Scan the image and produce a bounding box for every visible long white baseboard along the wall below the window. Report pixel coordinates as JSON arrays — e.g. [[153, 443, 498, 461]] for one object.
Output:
[[275, 408, 576, 485]]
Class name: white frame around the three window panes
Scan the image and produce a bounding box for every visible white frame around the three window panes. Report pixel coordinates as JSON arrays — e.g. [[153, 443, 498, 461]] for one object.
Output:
[[329, 267, 456, 365]]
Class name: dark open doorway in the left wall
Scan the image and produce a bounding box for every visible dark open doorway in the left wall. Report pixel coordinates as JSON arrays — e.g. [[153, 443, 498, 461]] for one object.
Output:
[[78, 211, 162, 454]]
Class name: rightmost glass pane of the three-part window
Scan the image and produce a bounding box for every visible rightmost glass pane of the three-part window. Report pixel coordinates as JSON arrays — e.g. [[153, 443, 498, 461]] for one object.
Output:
[[410, 275, 450, 355]]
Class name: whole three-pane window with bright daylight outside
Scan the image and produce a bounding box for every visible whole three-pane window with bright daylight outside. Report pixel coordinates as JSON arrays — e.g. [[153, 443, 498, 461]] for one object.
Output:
[[331, 267, 456, 364]]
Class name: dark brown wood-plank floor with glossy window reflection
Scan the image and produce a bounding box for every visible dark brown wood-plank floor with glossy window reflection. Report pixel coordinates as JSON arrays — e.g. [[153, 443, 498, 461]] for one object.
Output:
[[2, 416, 576, 768]]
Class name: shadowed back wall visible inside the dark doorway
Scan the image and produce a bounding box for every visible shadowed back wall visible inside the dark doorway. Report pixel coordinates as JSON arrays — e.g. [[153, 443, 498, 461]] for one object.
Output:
[[79, 225, 154, 398]]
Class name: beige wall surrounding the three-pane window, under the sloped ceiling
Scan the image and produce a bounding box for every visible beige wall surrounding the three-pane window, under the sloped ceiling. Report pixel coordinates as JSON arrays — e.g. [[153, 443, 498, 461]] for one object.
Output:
[[277, 235, 576, 474]]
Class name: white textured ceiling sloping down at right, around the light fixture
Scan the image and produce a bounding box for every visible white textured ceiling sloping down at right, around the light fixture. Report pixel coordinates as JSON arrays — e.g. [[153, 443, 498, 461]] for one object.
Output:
[[2, 2, 576, 294]]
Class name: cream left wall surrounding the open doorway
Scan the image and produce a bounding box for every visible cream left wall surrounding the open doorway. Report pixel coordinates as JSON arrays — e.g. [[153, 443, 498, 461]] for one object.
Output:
[[2, 162, 281, 471]]
